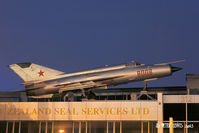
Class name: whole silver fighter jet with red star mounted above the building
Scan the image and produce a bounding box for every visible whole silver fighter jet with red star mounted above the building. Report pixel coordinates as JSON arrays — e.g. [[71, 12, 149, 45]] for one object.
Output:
[[9, 60, 184, 97]]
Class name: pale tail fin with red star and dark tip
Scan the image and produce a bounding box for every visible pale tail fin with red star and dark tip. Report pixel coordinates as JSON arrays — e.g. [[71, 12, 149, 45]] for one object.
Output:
[[9, 62, 64, 82]]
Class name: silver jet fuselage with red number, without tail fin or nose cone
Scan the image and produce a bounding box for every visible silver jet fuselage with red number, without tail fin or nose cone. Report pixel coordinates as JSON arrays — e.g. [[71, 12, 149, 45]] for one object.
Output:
[[25, 65, 176, 95]]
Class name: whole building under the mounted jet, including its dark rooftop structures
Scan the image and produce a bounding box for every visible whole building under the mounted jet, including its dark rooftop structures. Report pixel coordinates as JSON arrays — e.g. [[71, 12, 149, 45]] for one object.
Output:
[[0, 75, 199, 133]]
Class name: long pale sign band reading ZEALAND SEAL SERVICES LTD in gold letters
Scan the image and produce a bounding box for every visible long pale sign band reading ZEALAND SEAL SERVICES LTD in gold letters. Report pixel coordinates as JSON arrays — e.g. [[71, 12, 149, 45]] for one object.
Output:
[[0, 101, 158, 120]]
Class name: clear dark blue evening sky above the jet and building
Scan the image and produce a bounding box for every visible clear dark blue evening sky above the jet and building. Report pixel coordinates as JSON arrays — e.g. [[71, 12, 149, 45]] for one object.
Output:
[[0, 0, 199, 91]]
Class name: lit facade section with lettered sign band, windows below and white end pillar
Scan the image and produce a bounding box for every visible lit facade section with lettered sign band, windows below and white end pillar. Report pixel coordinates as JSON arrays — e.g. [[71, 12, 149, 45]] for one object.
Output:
[[0, 94, 162, 133]]
